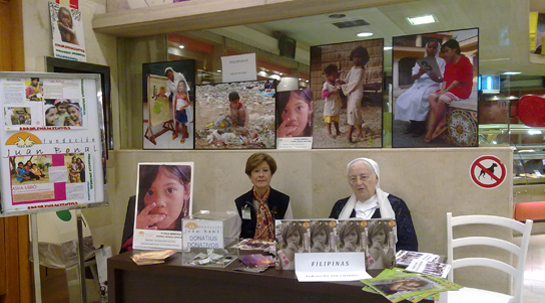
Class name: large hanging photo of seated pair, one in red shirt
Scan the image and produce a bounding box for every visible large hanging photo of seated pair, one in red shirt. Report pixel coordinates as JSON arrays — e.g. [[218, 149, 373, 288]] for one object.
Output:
[[392, 28, 479, 148]]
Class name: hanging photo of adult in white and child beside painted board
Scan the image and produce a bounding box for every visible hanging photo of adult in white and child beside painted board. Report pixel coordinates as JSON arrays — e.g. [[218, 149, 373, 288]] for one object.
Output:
[[142, 60, 195, 149]]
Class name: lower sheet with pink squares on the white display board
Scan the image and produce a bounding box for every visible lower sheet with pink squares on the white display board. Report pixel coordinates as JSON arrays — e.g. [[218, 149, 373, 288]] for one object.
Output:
[[2, 145, 96, 211]]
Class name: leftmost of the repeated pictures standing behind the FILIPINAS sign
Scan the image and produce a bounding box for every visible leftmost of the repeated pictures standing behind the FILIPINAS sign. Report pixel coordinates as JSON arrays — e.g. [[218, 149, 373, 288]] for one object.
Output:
[[276, 220, 310, 270]]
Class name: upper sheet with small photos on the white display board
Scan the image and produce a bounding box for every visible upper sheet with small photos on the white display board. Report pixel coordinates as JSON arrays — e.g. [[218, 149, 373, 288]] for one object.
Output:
[[0, 78, 87, 131]]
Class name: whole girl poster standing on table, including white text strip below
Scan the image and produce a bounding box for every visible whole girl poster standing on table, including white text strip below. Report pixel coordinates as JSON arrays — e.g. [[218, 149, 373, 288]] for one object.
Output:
[[133, 162, 194, 250]]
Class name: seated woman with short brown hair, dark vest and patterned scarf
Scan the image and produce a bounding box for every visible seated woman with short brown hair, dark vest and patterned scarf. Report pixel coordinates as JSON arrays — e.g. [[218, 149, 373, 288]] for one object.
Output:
[[235, 153, 293, 241]]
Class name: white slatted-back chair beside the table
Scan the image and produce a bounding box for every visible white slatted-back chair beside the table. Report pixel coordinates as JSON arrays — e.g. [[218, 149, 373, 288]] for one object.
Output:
[[439, 213, 533, 303]]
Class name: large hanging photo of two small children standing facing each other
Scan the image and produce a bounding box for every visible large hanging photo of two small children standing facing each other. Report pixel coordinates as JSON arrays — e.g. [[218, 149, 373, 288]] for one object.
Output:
[[310, 39, 384, 148]]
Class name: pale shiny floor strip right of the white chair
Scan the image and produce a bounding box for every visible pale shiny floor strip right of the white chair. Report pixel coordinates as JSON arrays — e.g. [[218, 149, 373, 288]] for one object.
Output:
[[522, 234, 545, 303]]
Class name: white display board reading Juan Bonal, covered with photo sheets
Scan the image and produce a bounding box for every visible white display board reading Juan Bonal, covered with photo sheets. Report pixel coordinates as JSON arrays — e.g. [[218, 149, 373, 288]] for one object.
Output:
[[0, 72, 107, 217]]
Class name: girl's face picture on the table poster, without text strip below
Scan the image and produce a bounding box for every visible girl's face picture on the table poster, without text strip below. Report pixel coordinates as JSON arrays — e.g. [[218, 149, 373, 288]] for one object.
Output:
[[135, 163, 192, 231]]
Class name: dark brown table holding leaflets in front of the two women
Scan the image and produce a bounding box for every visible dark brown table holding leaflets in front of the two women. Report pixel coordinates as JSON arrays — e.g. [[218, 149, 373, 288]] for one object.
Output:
[[108, 251, 429, 303]]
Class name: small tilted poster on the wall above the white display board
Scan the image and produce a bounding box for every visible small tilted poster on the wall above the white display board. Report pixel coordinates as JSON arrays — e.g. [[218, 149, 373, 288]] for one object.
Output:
[[49, 2, 87, 62]]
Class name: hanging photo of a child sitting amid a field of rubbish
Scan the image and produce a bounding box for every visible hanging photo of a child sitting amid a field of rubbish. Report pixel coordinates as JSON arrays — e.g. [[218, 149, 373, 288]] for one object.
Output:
[[195, 80, 276, 149]]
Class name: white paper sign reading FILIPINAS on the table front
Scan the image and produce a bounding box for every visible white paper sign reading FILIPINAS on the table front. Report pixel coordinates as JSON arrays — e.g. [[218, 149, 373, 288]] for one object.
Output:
[[295, 252, 371, 282]]
